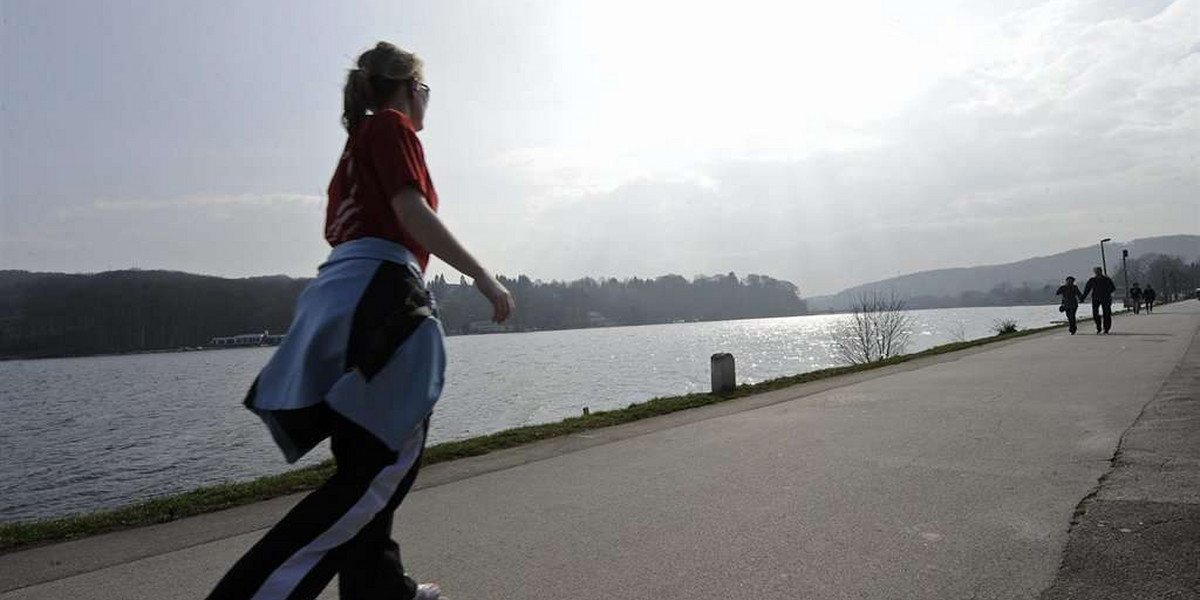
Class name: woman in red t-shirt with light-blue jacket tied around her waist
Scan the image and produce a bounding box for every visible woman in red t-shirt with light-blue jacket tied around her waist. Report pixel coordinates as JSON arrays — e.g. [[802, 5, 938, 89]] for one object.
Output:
[[209, 42, 514, 600]]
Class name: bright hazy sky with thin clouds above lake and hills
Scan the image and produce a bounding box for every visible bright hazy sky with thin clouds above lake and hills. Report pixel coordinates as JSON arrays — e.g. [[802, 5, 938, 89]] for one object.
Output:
[[0, 0, 1200, 295]]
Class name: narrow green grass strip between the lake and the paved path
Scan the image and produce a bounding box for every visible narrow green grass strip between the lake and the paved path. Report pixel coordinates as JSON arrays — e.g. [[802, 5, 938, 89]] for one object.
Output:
[[0, 323, 1066, 553]]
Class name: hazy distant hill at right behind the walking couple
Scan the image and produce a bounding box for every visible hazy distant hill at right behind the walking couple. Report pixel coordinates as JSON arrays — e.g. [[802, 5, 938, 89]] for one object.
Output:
[[808, 235, 1200, 312]]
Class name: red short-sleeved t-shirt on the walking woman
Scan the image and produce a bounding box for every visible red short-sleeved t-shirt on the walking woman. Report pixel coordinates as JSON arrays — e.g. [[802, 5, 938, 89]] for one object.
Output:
[[325, 109, 438, 270]]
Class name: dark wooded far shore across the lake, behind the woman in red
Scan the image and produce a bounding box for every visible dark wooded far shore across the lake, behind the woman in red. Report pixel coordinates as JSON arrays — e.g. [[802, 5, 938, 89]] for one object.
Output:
[[0, 270, 805, 358]]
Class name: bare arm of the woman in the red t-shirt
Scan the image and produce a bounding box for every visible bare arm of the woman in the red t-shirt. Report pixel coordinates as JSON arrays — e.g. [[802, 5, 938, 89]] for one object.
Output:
[[391, 186, 516, 323]]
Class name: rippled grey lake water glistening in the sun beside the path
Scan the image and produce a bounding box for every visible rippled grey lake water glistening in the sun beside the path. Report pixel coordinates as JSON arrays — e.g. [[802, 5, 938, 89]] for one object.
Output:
[[0, 306, 1058, 522]]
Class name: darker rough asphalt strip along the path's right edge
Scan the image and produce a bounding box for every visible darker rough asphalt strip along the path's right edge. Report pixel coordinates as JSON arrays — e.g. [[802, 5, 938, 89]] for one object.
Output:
[[1042, 302, 1200, 600]]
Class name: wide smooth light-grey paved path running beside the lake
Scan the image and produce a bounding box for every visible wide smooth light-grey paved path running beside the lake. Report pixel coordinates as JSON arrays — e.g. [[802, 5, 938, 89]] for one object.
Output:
[[7, 302, 1200, 600]]
